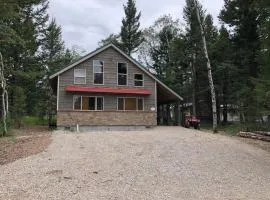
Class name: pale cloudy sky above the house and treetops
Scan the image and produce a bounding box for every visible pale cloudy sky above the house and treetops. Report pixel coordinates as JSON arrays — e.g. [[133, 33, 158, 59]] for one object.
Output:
[[49, 0, 223, 52]]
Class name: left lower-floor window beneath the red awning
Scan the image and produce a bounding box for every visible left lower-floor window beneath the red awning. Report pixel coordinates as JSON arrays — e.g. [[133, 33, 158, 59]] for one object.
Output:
[[73, 96, 104, 110]]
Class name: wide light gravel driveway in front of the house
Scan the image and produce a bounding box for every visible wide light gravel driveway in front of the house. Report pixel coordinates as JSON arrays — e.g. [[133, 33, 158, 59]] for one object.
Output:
[[0, 127, 270, 200]]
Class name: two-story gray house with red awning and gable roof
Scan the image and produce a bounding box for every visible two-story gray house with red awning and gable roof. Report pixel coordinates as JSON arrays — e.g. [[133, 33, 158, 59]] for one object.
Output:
[[50, 44, 182, 128]]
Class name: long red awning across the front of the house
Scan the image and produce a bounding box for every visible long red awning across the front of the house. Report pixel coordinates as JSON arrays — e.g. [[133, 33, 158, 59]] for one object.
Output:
[[65, 85, 151, 95]]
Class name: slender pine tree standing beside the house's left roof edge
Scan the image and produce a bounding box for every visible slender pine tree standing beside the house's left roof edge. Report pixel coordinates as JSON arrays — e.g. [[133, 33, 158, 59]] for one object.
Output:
[[36, 19, 67, 124]]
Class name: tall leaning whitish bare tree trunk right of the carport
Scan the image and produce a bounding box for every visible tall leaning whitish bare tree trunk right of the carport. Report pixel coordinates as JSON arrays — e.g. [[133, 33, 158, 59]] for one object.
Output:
[[194, 0, 217, 132]]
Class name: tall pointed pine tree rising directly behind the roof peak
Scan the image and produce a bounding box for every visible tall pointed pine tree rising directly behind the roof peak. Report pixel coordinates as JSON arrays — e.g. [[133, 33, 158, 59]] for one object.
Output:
[[120, 0, 143, 55]]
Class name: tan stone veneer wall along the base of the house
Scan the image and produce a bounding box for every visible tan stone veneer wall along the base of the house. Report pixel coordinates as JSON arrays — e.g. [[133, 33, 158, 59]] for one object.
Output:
[[57, 111, 157, 127]]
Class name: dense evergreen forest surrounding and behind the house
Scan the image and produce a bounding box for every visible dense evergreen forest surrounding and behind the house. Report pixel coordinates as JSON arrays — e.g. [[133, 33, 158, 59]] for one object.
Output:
[[0, 0, 270, 135]]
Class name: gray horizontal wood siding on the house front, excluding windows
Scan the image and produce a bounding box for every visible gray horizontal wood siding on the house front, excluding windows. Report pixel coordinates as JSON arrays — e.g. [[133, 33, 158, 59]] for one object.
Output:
[[58, 47, 156, 112]]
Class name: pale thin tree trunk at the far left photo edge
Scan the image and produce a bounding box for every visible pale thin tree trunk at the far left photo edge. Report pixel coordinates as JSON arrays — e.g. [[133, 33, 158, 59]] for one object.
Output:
[[0, 52, 8, 136]]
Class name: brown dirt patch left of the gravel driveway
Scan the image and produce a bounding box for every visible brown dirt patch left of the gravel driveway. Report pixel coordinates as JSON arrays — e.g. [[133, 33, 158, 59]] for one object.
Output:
[[0, 126, 51, 165]]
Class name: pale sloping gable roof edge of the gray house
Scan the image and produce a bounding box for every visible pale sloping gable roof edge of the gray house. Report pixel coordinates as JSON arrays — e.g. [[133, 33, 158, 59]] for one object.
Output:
[[49, 43, 183, 101]]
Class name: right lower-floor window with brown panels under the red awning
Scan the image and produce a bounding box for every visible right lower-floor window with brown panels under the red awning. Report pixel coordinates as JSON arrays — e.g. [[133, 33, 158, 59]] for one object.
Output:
[[117, 97, 143, 110]]
